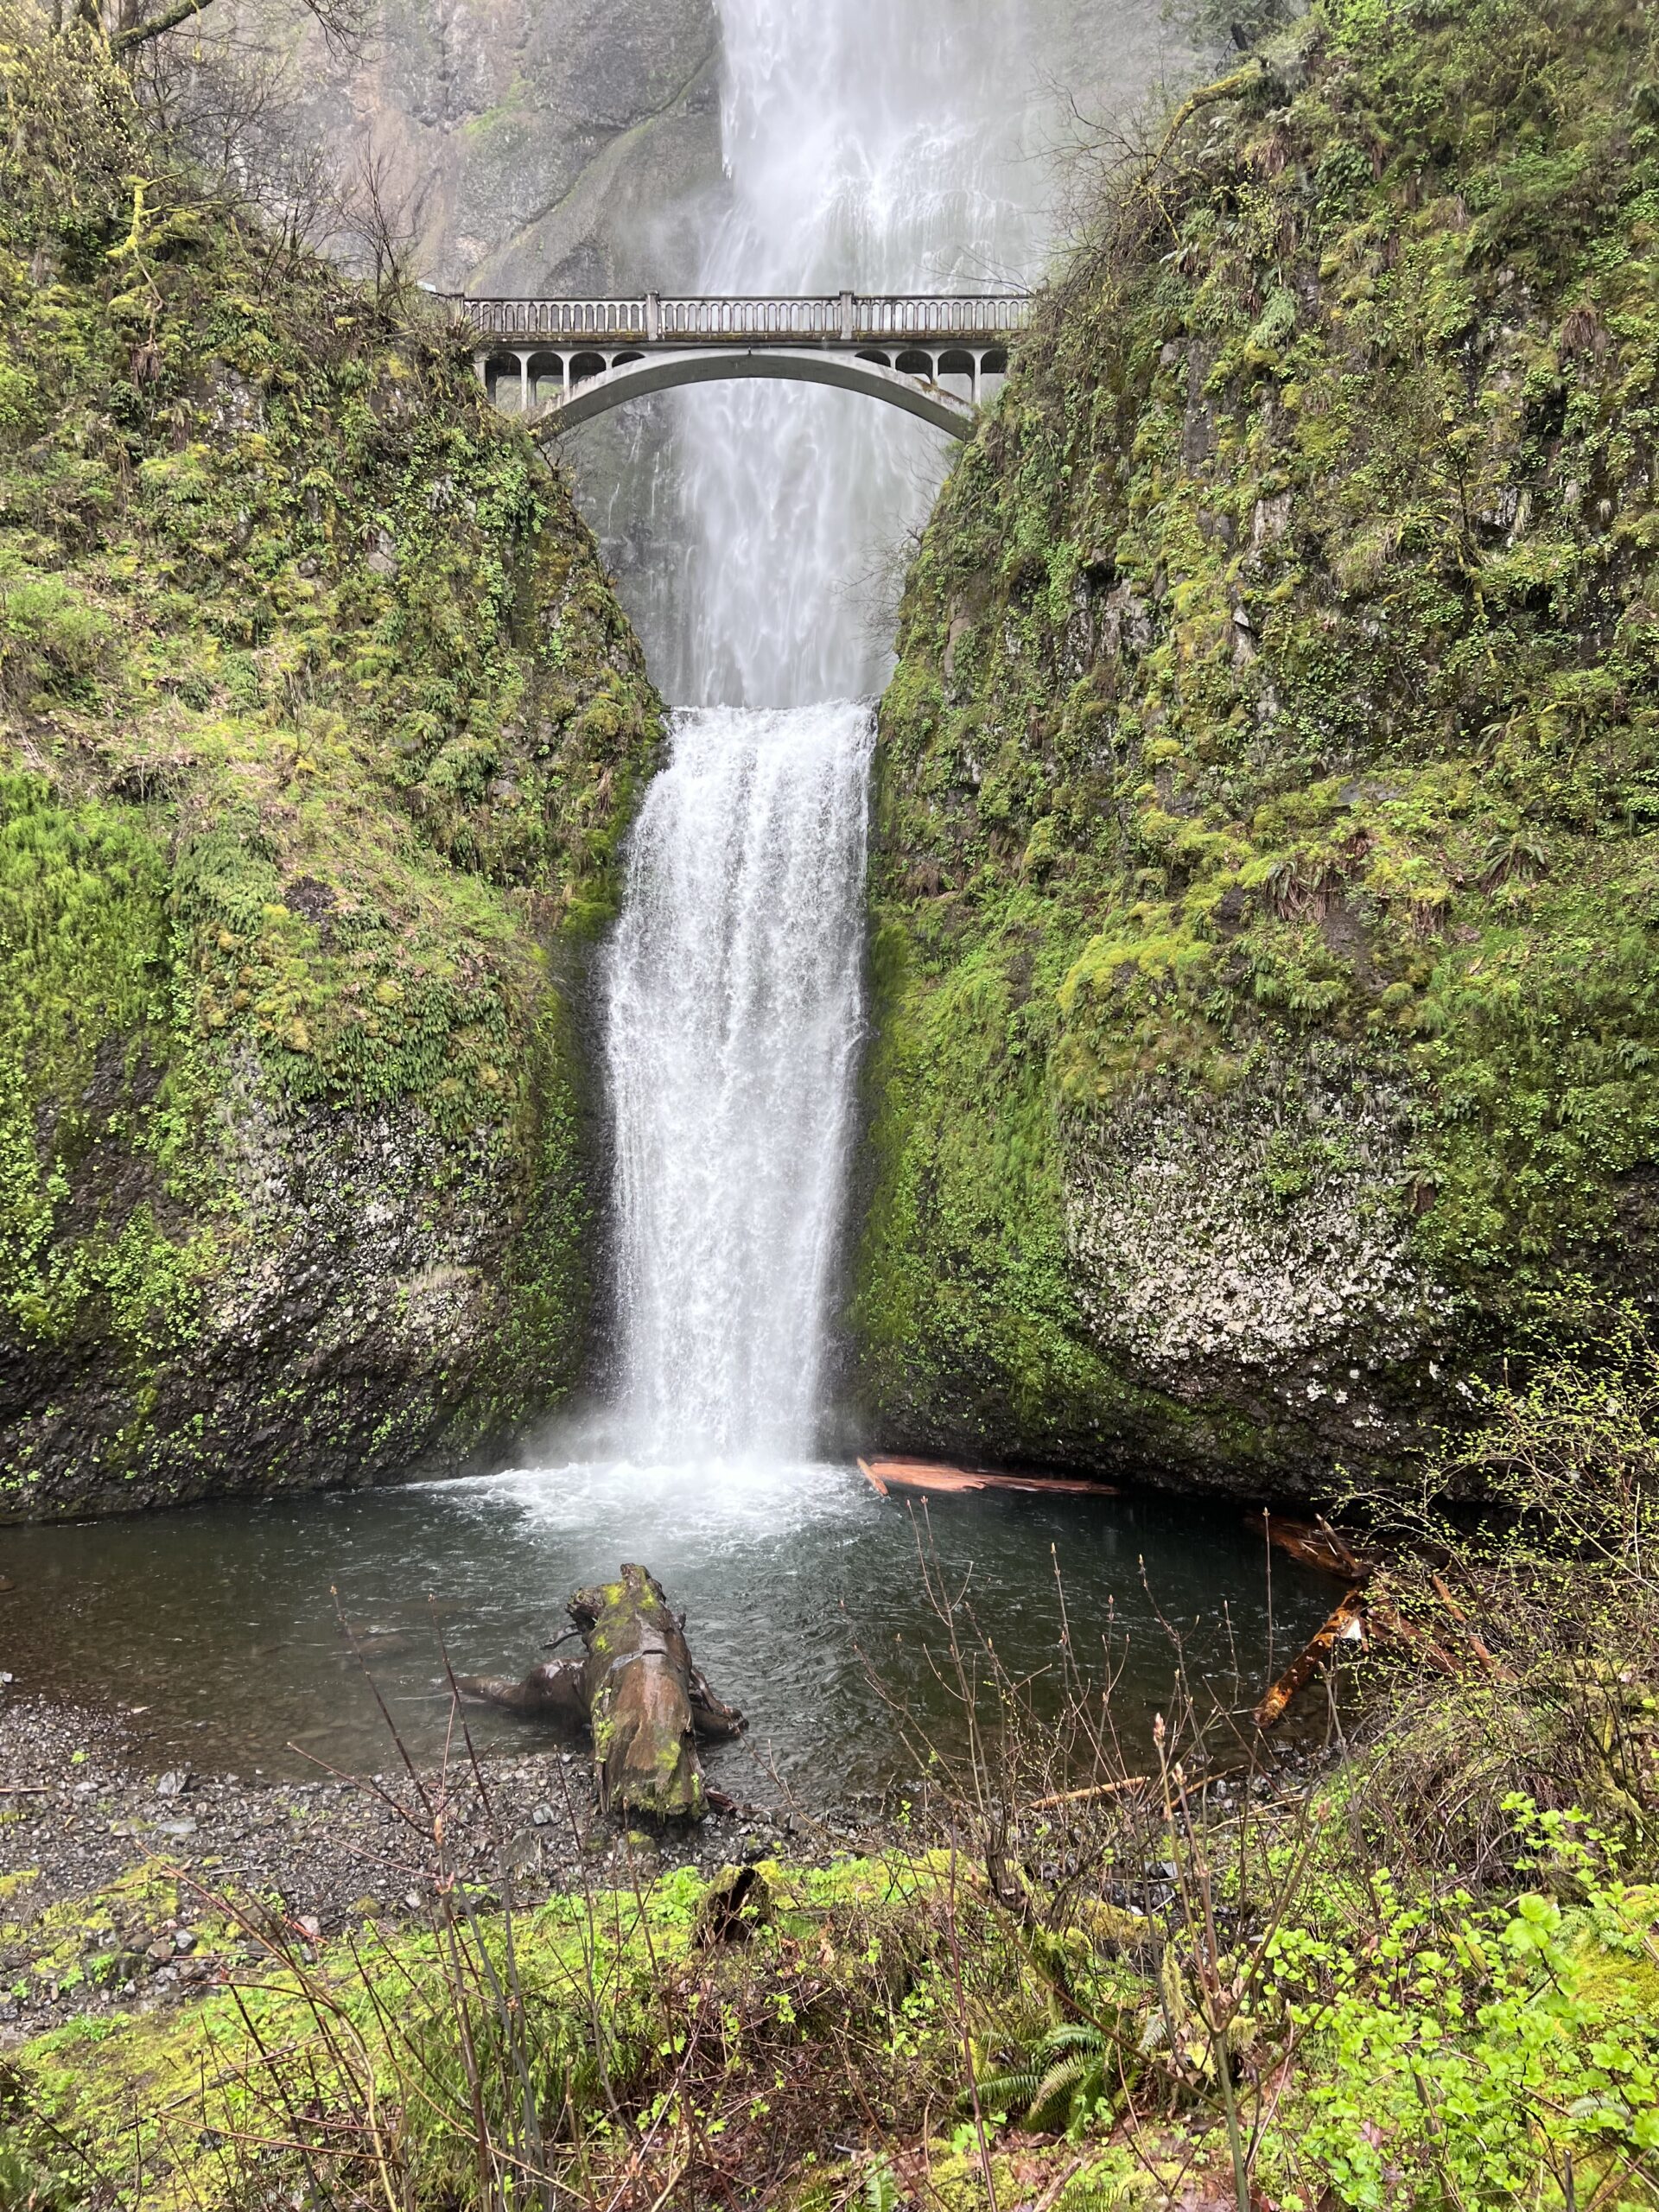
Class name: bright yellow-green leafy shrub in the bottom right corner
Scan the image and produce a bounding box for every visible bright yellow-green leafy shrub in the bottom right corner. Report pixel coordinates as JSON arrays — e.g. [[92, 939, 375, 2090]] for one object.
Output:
[[1261, 1801, 1659, 2212]]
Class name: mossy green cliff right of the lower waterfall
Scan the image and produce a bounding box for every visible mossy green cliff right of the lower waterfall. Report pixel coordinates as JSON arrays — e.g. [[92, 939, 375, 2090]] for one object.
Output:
[[854, 0, 1659, 1486]]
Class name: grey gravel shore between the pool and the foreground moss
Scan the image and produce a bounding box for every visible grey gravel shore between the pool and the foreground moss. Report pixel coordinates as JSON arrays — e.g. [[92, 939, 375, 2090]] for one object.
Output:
[[0, 1697, 812, 2049]]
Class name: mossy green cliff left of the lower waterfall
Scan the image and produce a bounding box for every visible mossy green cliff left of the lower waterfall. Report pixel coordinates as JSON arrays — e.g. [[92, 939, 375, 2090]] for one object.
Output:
[[0, 16, 659, 1517]]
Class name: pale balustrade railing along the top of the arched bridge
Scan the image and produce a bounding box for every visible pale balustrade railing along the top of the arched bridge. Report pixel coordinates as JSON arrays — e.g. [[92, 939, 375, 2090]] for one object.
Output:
[[445, 292, 1031, 345]]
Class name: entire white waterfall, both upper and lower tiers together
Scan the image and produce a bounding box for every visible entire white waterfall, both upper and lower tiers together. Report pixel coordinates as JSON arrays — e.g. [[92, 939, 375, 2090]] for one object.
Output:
[[606, 0, 1071, 1458]]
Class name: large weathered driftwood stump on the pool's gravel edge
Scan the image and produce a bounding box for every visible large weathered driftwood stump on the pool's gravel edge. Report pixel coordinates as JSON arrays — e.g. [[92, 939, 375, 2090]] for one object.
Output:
[[460, 1566, 743, 1821]]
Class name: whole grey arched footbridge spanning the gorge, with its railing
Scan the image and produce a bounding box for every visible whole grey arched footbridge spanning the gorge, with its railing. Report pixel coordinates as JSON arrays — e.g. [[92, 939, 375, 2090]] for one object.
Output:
[[449, 292, 1031, 438]]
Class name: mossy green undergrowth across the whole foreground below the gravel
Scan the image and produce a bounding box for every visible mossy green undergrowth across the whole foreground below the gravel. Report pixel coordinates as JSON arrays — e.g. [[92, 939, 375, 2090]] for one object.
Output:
[[0, 1798, 1659, 2212]]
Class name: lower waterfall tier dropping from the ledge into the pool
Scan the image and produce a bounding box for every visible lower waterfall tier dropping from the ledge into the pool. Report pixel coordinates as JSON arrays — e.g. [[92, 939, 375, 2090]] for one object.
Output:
[[604, 702, 872, 1458]]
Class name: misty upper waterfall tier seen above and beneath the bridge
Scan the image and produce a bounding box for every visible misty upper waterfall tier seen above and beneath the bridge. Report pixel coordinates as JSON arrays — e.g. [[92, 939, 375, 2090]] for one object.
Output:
[[666, 0, 1052, 706]]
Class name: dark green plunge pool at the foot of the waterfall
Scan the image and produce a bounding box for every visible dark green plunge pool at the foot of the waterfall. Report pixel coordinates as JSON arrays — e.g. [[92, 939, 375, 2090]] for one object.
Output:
[[0, 1462, 1334, 1802]]
